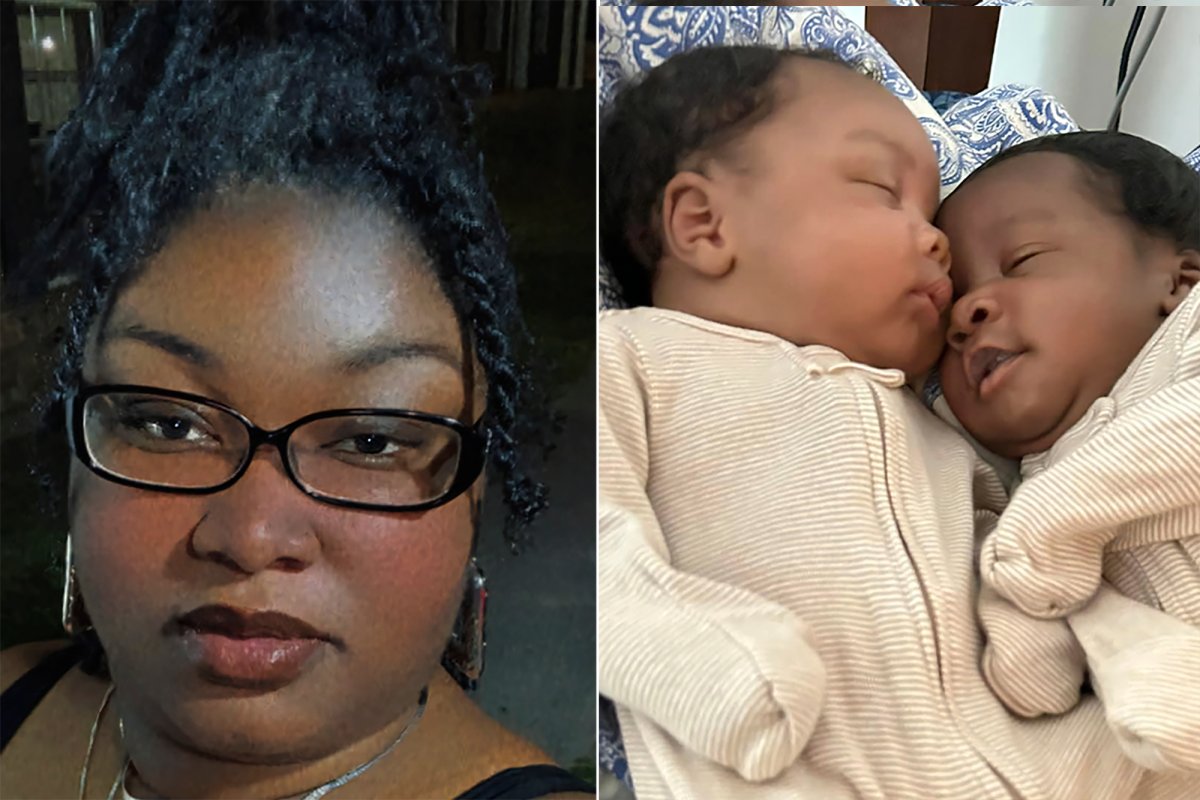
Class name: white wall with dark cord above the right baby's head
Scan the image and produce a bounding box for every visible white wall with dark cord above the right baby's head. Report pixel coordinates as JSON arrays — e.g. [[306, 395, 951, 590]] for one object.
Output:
[[990, 7, 1200, 155]]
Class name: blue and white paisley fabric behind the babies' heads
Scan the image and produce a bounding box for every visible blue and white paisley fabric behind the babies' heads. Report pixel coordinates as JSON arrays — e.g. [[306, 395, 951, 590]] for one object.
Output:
[[598, 0, 1078, 307]]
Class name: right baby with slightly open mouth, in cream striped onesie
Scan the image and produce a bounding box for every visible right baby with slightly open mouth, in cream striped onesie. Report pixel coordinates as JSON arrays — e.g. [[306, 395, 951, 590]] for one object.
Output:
[[937, 132, 1200, 780]]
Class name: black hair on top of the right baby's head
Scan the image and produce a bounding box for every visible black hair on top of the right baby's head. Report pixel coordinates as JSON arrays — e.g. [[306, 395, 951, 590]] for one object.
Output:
[[955, 131, 1200, 249]]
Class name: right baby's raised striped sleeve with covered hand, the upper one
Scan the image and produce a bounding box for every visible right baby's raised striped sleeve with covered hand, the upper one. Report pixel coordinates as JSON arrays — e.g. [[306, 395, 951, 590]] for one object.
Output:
[[979, 377, 1200, 618]]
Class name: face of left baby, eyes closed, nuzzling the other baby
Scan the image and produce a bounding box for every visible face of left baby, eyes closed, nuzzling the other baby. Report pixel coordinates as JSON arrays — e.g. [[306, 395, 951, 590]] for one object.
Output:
[[714, 62, 952, 375]]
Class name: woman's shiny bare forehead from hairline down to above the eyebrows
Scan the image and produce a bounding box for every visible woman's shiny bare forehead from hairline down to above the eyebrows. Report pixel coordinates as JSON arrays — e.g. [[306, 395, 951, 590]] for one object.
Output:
[[118, 190, 458, 347]]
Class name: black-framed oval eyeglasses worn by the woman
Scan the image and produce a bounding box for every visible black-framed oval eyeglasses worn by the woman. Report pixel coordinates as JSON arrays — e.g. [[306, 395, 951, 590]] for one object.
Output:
[[67, 384, 488, 511]]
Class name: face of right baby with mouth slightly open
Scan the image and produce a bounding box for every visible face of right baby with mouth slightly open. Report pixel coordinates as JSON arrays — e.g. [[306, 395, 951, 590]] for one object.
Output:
[[937, 152, 1162, 458]]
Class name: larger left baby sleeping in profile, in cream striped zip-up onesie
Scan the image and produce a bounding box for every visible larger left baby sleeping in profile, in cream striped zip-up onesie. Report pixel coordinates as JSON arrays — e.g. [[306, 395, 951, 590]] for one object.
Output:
[[598, 47, 1142, 800]]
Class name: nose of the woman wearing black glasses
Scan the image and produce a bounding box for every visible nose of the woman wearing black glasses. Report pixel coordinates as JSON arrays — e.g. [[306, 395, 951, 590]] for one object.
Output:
[[190, 447, 320, 575]]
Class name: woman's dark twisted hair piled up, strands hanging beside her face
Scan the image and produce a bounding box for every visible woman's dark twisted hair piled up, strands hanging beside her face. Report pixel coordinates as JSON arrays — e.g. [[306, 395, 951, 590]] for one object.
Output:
[[30, 0, 546, 546]]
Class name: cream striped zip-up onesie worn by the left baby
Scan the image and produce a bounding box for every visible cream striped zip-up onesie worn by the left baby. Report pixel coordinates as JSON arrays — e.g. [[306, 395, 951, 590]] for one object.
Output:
[[598, 308, 1142, 800]]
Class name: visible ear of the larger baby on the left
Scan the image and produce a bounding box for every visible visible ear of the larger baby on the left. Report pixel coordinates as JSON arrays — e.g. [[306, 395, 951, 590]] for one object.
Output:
[[662, 172, 733, 278]]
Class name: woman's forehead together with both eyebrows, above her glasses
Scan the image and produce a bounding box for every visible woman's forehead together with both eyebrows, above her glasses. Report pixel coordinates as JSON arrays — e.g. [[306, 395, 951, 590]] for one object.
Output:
[[88, 190, 463, 412]]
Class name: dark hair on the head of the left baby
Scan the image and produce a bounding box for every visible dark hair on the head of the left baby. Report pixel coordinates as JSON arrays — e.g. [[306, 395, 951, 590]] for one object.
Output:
[[600, 44, 872, 306]]
